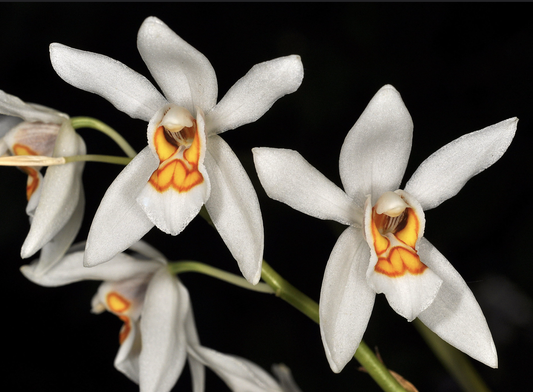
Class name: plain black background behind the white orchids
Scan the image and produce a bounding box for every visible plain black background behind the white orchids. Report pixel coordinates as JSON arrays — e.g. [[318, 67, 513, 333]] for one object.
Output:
[[0, 3, 533, 391]]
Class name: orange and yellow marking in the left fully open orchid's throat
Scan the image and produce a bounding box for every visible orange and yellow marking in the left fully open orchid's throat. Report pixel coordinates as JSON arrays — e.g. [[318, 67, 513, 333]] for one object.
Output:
[[148, 125, 204, 193]]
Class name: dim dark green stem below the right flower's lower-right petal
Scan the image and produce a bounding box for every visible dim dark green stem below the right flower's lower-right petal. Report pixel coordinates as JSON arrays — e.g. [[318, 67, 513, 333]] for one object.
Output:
[[413, 319, 490, 392]]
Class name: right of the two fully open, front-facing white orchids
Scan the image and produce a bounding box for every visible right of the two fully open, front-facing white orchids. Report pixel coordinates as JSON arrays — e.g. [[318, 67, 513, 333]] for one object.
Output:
[[253, 86, 518, 372]]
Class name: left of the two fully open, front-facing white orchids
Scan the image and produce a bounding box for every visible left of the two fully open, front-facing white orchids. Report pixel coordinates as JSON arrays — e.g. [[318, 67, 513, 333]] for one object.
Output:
[[50, 17, 303, 283]]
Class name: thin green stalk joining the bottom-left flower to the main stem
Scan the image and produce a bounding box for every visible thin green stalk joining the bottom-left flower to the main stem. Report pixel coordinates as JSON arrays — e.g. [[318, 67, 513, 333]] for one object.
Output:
[[168, 261, 274, 294]]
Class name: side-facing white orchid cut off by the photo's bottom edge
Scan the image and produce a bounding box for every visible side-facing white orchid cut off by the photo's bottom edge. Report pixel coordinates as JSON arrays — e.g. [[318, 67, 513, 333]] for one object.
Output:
[[21, 241, 296, 392]]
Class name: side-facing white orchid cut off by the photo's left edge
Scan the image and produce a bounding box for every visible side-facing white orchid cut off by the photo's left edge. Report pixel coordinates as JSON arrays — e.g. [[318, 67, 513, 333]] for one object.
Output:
[[0, 91, 85, 274]]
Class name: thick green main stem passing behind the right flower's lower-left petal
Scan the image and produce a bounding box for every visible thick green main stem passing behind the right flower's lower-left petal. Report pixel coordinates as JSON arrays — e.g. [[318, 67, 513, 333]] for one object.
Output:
[[261, 260, 405, 392]]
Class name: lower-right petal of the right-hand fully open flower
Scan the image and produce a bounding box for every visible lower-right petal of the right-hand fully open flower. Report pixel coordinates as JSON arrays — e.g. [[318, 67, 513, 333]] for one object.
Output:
[[418, 238, 498, 368]]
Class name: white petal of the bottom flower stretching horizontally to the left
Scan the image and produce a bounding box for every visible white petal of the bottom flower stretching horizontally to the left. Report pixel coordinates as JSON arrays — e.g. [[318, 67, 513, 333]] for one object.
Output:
[[20, 251, 161, 287]]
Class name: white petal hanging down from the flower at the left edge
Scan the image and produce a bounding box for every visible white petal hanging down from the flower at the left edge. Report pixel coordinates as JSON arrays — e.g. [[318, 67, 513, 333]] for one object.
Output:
[[21, 121, 85, 258]]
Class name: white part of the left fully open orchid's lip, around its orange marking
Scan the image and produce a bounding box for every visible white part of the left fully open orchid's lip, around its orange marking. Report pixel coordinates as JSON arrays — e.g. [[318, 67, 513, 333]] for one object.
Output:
[[137, 108, 211, 235]]
